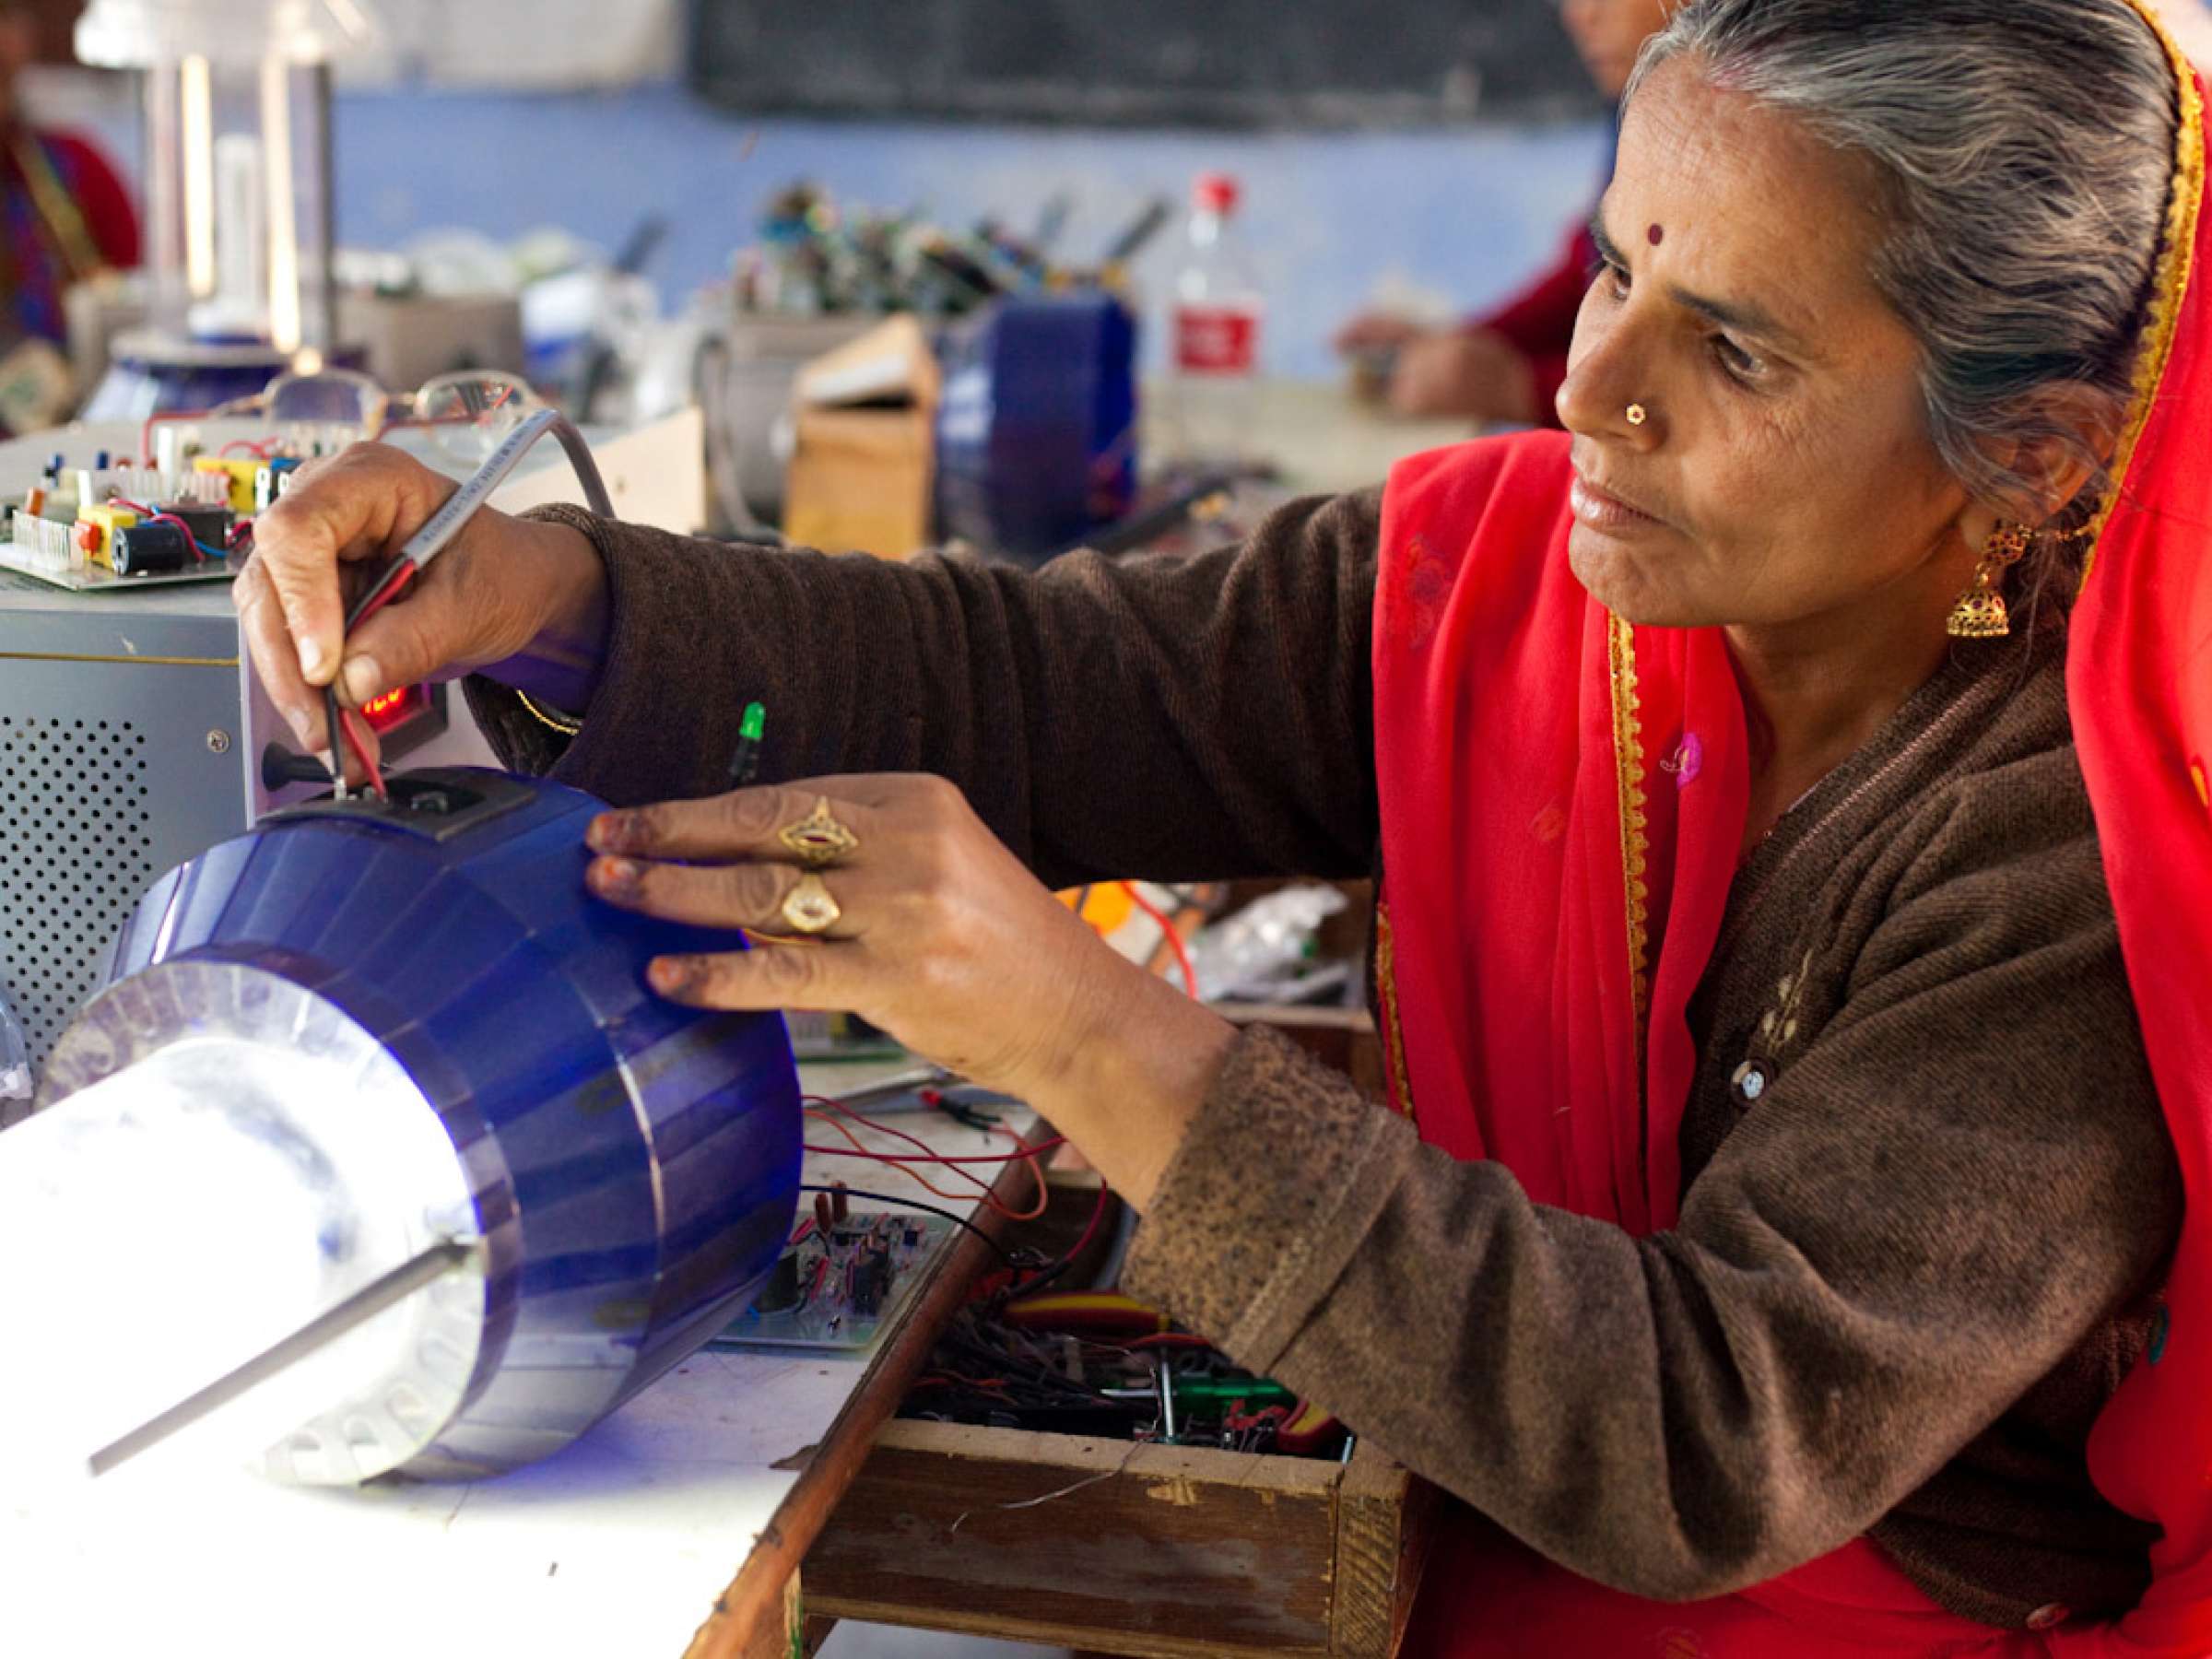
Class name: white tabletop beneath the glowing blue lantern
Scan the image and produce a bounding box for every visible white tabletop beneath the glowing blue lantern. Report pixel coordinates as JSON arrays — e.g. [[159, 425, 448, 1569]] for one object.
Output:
[[0, 1068, 1027, 1659]]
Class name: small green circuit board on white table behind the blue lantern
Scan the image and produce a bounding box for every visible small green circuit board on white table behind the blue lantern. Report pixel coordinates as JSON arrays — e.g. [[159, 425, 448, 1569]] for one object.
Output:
[[708, 1210, 953, 1354]]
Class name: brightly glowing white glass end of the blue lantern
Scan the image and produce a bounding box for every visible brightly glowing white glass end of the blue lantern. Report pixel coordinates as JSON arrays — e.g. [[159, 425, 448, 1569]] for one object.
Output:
[[0, 964, 482, 1491]]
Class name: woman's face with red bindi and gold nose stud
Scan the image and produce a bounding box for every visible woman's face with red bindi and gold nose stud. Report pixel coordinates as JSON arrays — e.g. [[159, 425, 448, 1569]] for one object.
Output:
[[1559, 60, 1973, 626]]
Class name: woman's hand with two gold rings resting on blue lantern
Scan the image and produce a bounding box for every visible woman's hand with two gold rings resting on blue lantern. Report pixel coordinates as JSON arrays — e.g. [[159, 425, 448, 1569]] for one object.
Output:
[[588, 774, 1232, 1206]]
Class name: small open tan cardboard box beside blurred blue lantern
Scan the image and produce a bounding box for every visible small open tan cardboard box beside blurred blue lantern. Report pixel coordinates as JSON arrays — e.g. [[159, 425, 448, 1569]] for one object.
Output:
[[783, 316, 942, 559]]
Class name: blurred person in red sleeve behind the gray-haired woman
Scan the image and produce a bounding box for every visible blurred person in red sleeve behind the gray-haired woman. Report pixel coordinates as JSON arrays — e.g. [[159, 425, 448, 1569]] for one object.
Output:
[[1336, 0, 1672, 427]]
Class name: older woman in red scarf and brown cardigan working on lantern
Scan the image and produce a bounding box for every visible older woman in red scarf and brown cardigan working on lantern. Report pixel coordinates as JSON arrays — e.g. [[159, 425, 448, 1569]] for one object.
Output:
[[239, 0, 2212, 1654]]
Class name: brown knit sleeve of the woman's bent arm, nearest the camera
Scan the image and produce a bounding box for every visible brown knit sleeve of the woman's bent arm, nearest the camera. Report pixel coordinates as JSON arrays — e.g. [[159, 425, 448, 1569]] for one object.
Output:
[[1126, 774, 2181, 1606]]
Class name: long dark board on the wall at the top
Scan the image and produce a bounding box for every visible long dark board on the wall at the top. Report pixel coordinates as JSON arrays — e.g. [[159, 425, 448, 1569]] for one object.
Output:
[[690, 0, 1597, 126]]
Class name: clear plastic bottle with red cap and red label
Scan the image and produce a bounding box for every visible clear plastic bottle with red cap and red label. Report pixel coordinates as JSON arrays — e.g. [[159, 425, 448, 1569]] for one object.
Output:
[[1168, 172, 1265, 466]]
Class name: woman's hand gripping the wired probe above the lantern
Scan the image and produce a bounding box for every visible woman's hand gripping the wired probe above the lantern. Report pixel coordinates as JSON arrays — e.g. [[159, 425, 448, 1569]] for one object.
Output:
[[232, 444, 606, 752]]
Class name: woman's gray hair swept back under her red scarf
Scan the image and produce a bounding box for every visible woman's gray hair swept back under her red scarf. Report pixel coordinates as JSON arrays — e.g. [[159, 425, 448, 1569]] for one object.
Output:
[[1628, 0, 2179, 586]]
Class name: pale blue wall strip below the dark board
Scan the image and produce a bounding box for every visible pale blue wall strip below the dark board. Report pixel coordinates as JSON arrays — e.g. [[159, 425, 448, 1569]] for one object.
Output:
[[336, 87, 1608, 378]]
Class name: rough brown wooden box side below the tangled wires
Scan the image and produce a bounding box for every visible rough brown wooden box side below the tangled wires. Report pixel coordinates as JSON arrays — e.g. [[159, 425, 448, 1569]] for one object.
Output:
[[806, 1420, 1436, 1659]]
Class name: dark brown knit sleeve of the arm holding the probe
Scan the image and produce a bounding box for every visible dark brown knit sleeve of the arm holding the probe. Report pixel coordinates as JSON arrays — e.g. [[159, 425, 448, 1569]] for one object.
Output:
[[469, 491, 1381, 885]]
